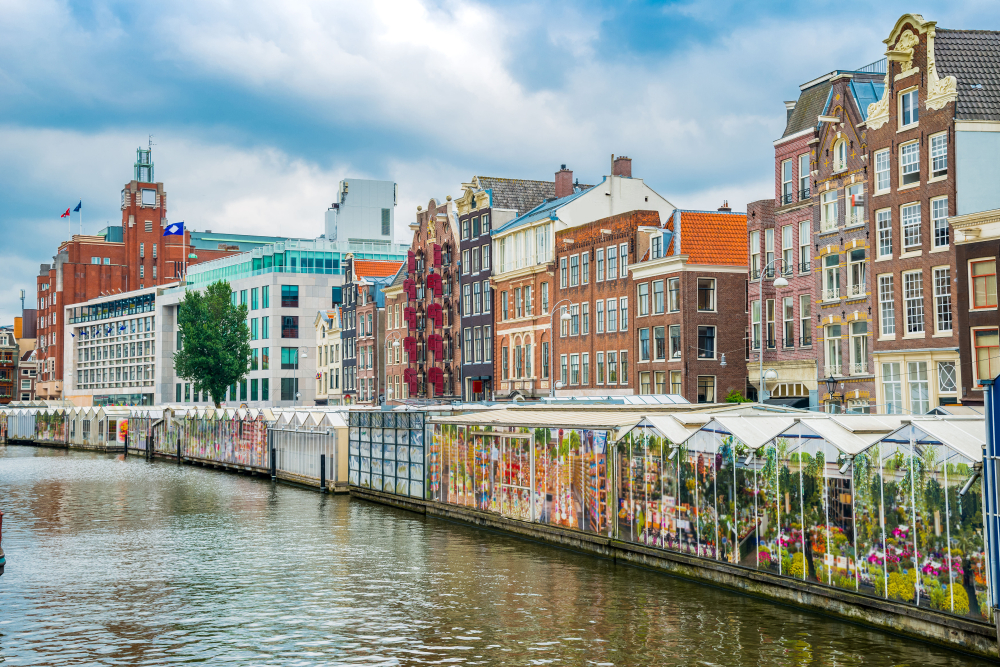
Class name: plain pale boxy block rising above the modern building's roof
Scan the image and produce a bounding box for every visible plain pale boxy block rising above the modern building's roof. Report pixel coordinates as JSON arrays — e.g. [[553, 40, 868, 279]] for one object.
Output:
[[326, 178, 397, 243]]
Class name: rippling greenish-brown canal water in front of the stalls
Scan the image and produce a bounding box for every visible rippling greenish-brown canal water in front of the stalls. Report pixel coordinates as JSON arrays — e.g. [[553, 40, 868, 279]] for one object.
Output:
[[0, 446, 979, 666]]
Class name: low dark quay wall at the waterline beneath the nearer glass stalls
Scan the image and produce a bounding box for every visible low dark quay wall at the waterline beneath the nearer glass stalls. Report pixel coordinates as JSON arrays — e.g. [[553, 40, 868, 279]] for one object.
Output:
[[350, 487, 1000, 661]]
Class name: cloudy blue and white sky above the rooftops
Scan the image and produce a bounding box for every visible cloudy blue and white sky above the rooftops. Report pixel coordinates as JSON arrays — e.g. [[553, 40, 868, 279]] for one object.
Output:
[[0, 0, 1000, 323]]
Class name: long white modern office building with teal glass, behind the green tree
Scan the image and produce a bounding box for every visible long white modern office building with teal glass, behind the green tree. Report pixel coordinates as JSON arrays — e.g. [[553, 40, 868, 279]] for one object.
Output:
[[63, 239, 408, 407]]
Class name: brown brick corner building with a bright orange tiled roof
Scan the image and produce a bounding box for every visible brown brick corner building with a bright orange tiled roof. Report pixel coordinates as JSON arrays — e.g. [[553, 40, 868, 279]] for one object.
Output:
[[631, 206, 747, 403]]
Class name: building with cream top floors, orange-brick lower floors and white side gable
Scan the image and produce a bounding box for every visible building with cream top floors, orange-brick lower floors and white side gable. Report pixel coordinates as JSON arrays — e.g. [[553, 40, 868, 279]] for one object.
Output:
[[491, 157, 674, 398]]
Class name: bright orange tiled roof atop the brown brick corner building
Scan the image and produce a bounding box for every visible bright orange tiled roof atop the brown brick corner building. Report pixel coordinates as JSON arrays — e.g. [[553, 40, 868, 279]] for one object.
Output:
[[667, 210, 748, 266]]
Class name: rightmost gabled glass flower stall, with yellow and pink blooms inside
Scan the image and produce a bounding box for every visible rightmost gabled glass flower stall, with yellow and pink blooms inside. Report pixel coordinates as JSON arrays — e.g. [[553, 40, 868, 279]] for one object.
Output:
[[869, 434, 990, 620]]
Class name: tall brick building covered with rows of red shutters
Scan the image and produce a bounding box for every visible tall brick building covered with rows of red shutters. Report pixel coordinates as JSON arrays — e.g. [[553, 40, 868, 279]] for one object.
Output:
[[403, 197, 462, 400]]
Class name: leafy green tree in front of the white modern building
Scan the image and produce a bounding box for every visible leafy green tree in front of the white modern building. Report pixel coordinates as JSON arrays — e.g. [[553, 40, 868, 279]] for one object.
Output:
[[174, 280, 250, 407]]
